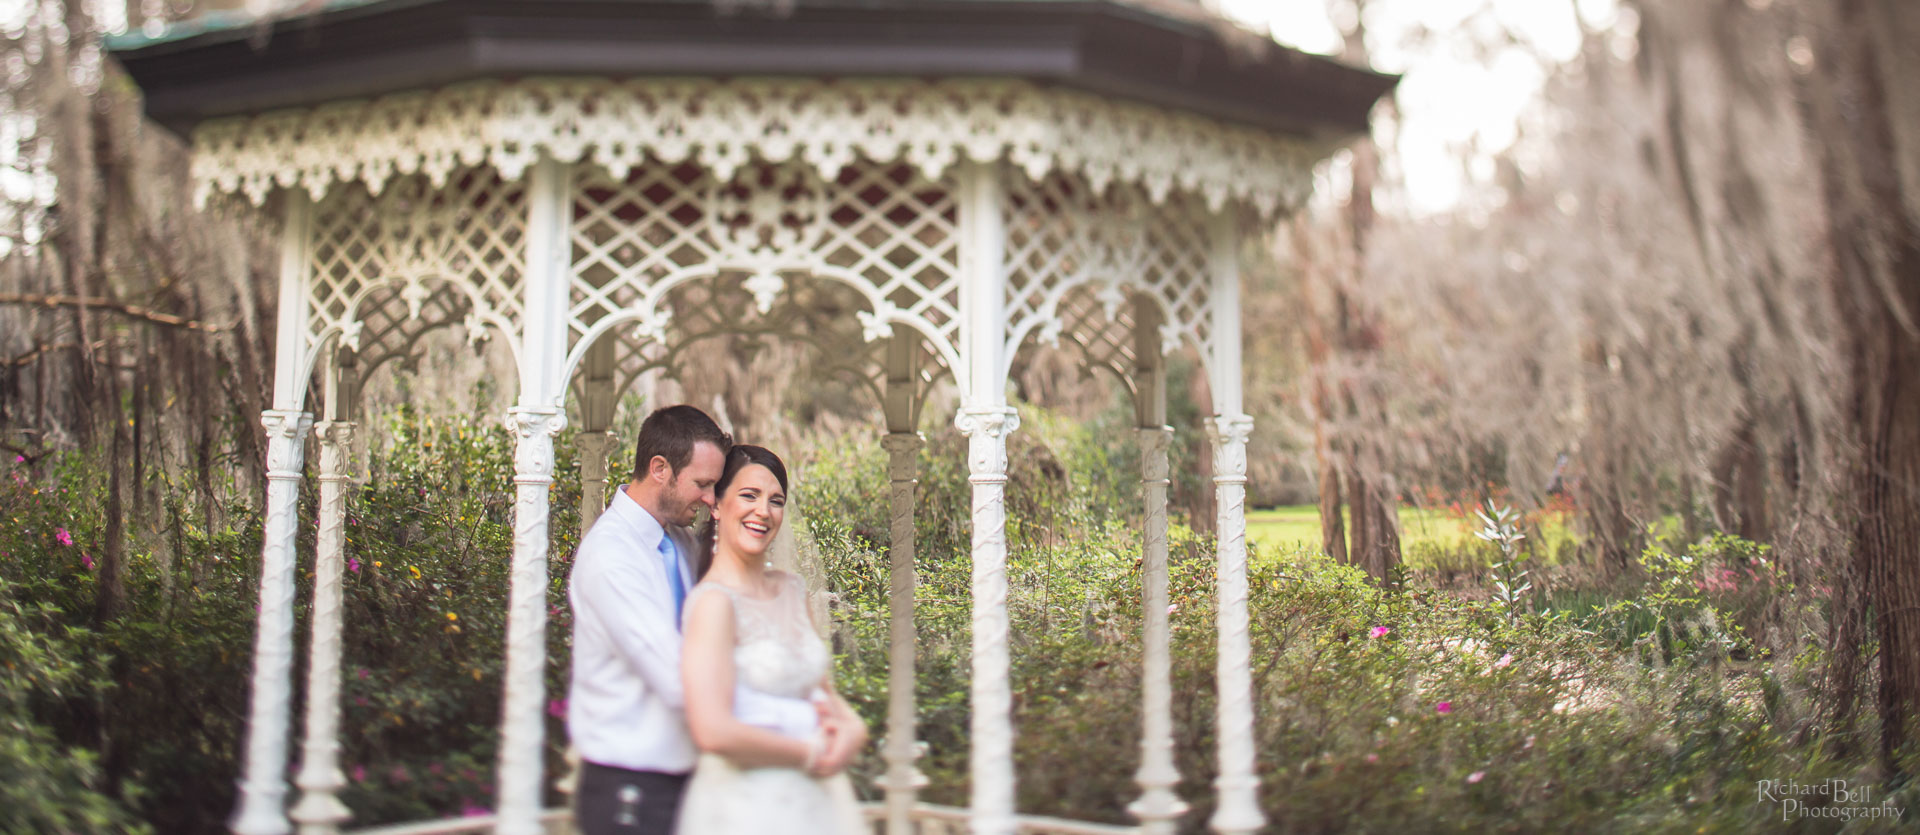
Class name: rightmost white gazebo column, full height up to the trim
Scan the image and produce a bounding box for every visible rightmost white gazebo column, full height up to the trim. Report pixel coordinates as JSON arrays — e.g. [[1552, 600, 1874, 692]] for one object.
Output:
[[1206, 213, 1267, 835]]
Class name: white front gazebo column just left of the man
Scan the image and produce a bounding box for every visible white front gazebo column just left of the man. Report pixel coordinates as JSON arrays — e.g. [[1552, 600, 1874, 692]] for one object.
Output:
[[495, 157, 572, 835]]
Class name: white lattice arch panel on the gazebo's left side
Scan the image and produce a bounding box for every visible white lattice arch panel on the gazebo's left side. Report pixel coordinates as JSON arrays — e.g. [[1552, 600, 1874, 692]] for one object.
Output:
[[307, 169, 526, 362]]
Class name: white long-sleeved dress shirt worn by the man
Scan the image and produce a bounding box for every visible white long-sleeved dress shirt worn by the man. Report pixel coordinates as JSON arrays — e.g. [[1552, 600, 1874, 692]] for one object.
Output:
[[566, 486, 820, 774]]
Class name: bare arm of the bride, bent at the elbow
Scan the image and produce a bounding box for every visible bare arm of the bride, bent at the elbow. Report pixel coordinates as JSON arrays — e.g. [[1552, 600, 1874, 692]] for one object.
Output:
[[680, 593, 818, 768]]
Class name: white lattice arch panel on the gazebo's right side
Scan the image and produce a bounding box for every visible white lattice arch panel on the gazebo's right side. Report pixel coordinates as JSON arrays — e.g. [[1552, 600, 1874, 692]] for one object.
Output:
[[1006, 177, 1212, 374]]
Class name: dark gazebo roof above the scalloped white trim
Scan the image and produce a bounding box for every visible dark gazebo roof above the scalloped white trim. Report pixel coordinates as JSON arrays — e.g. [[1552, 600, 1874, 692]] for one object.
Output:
[[109, 0, 1398, 140]]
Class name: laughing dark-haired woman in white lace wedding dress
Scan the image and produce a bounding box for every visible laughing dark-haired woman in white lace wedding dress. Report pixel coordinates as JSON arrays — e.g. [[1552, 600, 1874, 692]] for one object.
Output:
[[676, 445, 866, 835]]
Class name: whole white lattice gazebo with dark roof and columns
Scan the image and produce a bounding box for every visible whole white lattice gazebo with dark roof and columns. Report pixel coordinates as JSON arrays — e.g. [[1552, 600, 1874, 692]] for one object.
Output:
[[115, 0, 1394, 835]]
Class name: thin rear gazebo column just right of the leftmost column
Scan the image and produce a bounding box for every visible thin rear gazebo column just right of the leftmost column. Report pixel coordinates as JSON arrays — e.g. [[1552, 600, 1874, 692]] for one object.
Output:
[[292, 418, 353, 835]]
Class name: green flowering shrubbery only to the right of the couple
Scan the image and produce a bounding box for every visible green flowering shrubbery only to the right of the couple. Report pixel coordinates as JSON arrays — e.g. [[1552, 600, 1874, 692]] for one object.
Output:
[[799, 409, 1904, 833]]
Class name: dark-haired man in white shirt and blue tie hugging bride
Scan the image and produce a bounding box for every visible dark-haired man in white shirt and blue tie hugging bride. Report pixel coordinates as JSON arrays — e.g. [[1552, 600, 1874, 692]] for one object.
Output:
[[566, 405, 858, 835]]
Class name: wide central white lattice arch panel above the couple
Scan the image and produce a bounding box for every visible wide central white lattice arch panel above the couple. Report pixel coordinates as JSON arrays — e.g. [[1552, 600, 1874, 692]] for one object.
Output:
[[568, 163, 960, 386]]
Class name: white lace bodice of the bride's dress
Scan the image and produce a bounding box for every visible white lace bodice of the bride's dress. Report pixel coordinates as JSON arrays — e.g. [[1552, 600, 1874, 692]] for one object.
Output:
[[687, 572, 833, 699]]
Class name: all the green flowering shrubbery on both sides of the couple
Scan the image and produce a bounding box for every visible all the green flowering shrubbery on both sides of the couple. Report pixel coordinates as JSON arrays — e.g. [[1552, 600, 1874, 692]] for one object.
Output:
[[0, 401, 1889, 833]]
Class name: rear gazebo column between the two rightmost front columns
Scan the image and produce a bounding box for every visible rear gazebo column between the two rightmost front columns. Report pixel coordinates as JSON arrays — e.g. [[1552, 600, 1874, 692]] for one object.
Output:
[[1127, 296, 1187, 835]]
